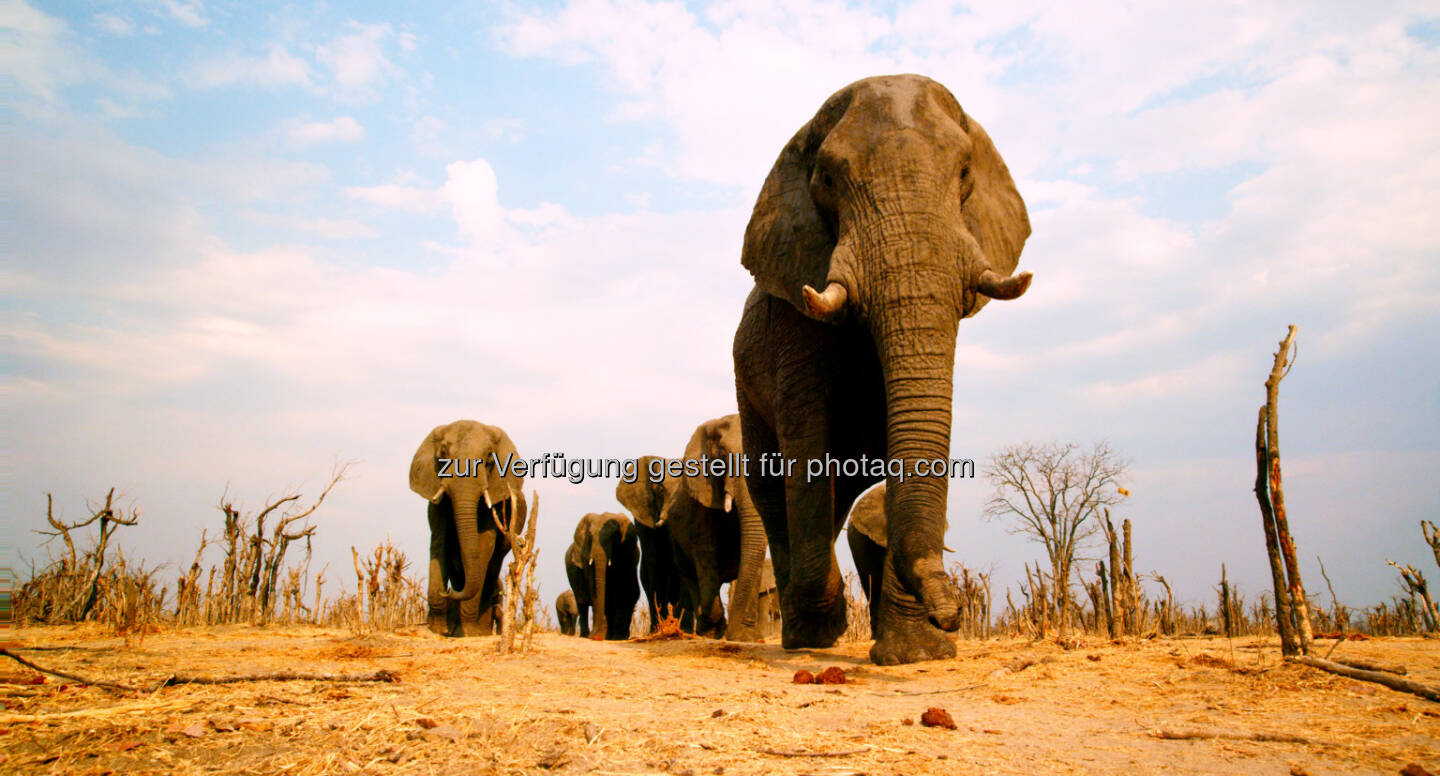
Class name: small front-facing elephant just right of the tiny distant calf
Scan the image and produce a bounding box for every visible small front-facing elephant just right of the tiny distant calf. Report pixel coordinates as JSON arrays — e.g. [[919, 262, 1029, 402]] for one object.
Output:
[[564, 513, 639, 641]]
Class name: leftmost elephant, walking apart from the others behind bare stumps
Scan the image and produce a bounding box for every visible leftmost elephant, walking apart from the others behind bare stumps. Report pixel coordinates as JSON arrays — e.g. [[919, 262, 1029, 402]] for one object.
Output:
[[410, 420, 526, 636]]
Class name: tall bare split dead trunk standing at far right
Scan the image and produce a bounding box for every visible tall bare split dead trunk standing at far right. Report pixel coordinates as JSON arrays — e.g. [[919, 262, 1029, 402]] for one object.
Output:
[[1254, 325, 1313, 655]]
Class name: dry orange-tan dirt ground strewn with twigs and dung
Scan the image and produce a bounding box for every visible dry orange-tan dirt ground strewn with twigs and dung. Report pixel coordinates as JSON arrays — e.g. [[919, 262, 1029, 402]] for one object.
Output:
[[0, 628, 1440, 776]]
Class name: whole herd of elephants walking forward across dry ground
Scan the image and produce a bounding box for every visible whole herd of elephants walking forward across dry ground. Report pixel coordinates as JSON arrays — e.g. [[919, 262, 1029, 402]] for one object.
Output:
[[410, 75, 1031, 664]]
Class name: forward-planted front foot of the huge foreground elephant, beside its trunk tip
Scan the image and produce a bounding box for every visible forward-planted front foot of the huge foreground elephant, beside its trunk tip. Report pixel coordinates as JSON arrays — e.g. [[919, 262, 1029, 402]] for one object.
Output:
[[870, 553, 959, 665]]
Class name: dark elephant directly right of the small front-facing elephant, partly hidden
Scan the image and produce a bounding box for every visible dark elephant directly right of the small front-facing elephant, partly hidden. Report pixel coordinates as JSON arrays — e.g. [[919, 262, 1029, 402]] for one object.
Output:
[[615, 455, 694, 631]]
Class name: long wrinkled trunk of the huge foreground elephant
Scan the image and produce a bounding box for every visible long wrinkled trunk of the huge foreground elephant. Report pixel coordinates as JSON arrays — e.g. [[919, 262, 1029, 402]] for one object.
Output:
[[871, 259, 959, 631]]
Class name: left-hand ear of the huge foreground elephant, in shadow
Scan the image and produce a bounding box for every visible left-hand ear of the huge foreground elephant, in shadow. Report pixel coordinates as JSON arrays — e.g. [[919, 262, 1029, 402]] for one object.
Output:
[[740, 84, 854, 315]]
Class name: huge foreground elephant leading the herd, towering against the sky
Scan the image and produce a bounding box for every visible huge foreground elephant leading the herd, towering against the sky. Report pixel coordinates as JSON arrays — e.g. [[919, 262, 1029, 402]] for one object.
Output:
[[734, 75, 1030, 664]]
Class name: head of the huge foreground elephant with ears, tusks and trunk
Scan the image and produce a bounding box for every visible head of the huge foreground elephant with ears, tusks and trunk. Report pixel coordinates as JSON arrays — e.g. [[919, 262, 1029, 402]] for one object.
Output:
[[742, 75, 1031, 644]]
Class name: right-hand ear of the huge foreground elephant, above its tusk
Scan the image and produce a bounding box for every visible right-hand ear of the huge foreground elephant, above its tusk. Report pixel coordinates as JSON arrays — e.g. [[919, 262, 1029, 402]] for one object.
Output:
[[956, 107, 1030, 317]]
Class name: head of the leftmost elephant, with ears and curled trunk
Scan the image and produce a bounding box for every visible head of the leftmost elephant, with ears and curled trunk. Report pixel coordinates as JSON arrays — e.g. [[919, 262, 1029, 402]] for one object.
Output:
[[410, 420, 526, 600]]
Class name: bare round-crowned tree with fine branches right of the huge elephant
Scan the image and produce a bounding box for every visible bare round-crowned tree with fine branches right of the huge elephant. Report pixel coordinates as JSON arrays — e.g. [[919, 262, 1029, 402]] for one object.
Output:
[[985, 442, 1126, 636]]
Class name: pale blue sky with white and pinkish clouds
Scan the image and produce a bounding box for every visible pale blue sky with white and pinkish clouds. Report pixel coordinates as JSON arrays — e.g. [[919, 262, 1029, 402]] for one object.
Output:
[[0, 0, 1440, 619]]
